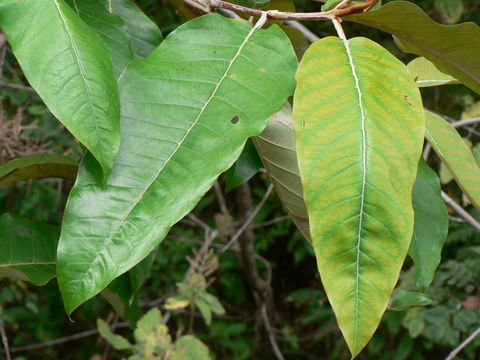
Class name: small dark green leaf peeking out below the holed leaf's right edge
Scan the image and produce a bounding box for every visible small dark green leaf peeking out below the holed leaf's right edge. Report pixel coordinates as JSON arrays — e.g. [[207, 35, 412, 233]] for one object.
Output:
[[225, 140, 262, 192]]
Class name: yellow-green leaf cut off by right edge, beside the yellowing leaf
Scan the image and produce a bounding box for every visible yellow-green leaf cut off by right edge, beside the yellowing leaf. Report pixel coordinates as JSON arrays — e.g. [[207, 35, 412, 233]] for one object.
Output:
[[425, 111, 480, 210]]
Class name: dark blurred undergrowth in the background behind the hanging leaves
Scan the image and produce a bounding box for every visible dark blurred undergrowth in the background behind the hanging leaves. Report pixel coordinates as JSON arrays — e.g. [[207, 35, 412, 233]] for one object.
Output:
[[0, 0, 480, 360]]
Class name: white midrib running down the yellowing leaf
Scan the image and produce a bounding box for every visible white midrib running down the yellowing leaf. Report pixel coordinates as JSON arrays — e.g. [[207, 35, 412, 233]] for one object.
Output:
[[343, 39, 367, 349]]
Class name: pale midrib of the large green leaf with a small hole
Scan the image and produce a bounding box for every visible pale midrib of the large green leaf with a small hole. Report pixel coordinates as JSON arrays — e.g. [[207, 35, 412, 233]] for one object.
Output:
[[68, 23, 257, 308]]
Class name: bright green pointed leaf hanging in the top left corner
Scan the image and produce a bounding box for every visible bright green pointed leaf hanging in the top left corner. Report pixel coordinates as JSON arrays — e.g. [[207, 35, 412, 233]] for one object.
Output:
[[0, 0, 120, 179]]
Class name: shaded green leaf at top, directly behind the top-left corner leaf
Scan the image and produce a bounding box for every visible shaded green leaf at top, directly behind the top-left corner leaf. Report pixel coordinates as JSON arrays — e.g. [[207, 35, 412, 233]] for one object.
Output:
[[67, 0, 134, 78]]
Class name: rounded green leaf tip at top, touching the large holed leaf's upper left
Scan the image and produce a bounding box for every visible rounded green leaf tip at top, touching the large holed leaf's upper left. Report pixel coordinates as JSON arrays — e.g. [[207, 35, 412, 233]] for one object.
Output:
[[108, 0, 163, 59]]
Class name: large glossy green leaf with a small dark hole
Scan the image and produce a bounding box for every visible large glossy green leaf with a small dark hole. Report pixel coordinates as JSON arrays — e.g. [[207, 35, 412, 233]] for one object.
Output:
[[57, 14, 297, 313]]
